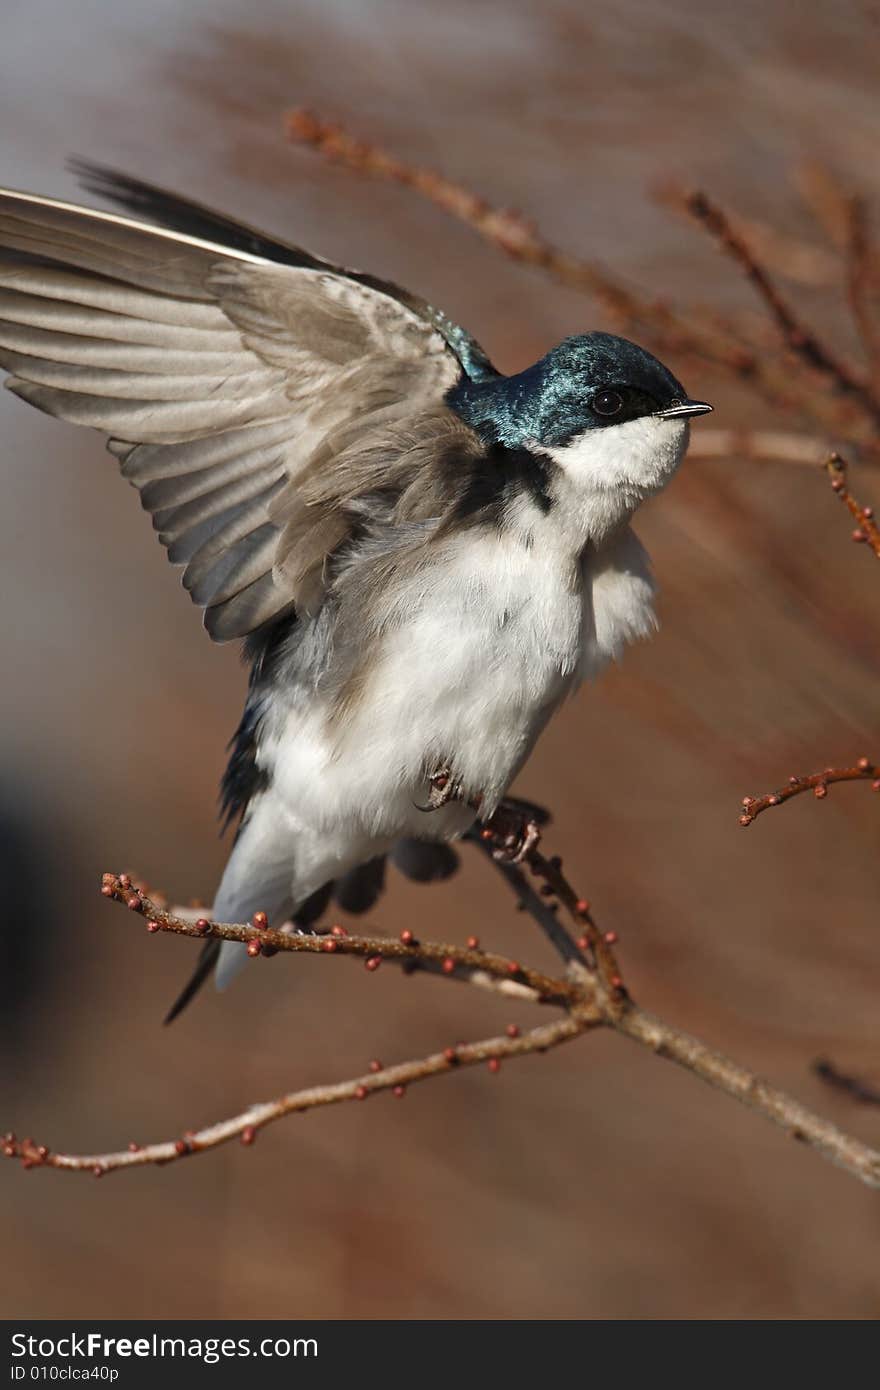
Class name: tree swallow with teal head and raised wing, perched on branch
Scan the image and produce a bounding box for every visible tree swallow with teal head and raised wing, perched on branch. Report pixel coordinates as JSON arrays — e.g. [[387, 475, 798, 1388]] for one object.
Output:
[[0, 164, 712, 1013]]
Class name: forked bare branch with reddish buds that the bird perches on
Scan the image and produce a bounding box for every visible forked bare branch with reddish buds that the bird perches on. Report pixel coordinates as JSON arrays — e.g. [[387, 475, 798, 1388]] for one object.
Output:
[[6, 849, 880, 1187]]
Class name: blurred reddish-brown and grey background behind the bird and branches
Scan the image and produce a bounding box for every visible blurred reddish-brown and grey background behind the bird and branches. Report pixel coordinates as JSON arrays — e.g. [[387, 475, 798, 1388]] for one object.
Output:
[[0, 0, 880, 1318]]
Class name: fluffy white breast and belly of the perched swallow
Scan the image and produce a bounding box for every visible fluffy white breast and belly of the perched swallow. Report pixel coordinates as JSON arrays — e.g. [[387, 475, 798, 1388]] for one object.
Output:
[[270, 527, 653, 838]]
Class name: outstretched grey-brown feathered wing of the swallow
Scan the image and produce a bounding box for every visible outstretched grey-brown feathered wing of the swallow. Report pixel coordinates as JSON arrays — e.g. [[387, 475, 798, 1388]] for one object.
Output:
[[0, 167, 492, 641]]
